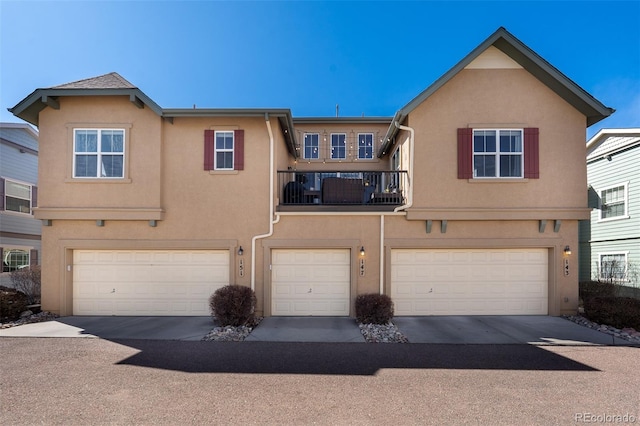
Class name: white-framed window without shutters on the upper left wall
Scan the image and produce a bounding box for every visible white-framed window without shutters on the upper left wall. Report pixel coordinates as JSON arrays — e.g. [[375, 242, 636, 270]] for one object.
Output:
[[73, 129, 125, 178]]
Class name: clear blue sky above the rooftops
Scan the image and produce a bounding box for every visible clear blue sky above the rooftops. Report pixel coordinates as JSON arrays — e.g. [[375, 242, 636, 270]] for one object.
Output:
[[0, 0, 640, 136]]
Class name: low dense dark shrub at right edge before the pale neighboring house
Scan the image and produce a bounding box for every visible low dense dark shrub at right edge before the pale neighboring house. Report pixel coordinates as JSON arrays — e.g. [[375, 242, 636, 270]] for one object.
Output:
[[584, 297, 640, 330]]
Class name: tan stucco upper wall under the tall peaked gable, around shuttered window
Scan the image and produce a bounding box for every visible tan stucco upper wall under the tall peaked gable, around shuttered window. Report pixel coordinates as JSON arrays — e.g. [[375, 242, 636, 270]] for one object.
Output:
[[408, 69, 586, 213]]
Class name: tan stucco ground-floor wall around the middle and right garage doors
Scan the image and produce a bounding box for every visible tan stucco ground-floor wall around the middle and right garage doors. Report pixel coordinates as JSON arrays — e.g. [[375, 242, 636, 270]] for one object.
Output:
[[261, 215, 578, 315]]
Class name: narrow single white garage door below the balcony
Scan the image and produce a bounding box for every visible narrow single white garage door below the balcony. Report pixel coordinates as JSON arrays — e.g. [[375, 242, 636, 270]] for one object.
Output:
[[271, 249, 351, 316]]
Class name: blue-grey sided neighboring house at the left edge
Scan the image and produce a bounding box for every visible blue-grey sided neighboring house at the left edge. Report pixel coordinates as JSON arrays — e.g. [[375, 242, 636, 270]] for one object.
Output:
[[0, 123, 42, 285]]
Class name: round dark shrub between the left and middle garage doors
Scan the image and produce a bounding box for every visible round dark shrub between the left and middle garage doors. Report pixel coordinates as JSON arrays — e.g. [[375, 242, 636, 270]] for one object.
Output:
[[209, 284, 256, 327]]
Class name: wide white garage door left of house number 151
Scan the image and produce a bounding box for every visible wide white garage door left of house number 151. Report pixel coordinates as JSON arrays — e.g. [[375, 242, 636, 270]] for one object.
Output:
[[73, 250, 229, 316]]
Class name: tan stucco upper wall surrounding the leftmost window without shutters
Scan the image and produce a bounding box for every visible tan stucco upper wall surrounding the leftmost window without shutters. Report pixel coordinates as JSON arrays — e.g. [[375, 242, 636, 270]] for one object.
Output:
[[36, 97, 162, 215]]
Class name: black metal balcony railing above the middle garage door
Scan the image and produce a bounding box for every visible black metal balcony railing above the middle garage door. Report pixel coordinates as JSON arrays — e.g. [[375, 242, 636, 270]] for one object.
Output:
[[278, 170, 407, 206]]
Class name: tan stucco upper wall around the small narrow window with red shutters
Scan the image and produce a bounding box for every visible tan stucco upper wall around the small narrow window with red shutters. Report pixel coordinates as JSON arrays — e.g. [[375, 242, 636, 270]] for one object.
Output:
[[162, 118, 269, 238]]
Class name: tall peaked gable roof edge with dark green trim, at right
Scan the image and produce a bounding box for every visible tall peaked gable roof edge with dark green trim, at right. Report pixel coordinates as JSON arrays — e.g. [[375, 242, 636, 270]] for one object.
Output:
[[378, 27, 615, 156]]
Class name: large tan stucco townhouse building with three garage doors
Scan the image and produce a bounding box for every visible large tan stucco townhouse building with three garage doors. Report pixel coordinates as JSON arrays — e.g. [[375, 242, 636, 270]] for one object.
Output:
[[11, 28, 613, 316]]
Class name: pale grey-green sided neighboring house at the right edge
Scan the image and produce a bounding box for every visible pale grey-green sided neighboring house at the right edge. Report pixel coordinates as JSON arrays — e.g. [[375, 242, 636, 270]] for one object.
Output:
[[580, 128, 640, 287]]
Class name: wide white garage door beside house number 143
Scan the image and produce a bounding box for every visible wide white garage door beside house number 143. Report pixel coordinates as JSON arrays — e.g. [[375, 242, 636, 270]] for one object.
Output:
[[391, 249, 548, 315]]
